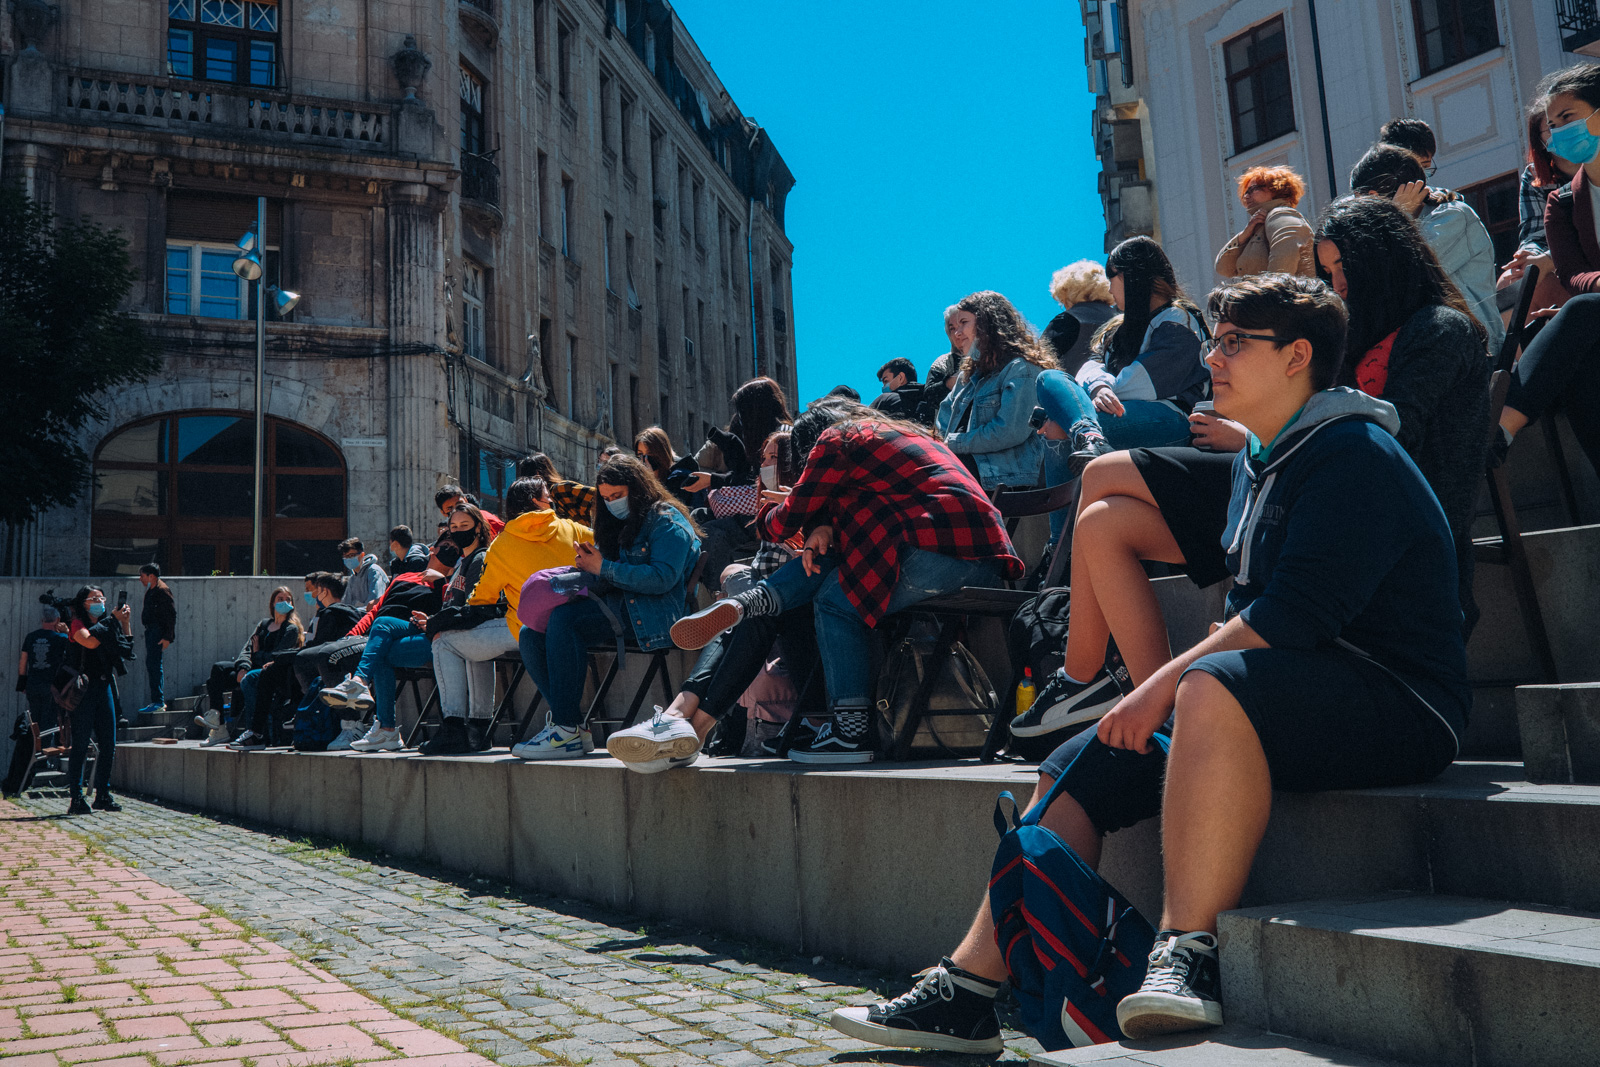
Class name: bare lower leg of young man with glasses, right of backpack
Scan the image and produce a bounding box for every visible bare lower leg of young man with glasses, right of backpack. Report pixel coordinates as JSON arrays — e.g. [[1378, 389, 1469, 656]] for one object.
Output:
[[1162, 670, 1272, 933]]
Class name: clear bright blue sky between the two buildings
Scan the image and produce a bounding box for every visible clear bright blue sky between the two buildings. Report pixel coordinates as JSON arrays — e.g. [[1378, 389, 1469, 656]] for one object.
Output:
[[674, 0, 1104, 402]]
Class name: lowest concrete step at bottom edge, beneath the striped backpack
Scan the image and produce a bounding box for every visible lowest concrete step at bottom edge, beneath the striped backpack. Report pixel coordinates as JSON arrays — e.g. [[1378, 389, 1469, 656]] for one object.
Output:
[[1029, 1024, 1398, 1067]]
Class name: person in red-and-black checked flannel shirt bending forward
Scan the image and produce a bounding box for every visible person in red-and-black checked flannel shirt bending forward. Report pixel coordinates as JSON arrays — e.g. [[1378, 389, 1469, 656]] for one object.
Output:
[[672, 400, 1024, 763]]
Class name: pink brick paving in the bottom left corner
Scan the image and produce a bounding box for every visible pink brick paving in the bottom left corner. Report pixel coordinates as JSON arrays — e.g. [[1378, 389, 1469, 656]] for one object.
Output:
[[0, 803, 488, 1067]]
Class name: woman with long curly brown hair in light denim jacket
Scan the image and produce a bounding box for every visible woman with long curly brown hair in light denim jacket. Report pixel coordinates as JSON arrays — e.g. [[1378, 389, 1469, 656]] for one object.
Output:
[[938, 290, 1056, 490]]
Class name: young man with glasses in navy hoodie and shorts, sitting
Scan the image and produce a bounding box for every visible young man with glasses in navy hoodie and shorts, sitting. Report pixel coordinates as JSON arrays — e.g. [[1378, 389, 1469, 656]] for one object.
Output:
[[832, 274, 1470, 1053]]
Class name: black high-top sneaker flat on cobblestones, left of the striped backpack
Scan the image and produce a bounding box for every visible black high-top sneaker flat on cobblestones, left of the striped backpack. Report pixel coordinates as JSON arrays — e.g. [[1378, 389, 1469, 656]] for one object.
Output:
[[829, 957, 1005, 1056]]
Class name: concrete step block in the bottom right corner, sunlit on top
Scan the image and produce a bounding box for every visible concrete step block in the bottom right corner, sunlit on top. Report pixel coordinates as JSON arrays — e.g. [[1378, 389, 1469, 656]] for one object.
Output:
[[1222, 896, 1600, 1067]]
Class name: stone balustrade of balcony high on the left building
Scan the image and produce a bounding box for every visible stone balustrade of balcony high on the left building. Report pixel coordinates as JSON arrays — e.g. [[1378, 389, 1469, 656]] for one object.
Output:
[[58, 70, 392, 152]]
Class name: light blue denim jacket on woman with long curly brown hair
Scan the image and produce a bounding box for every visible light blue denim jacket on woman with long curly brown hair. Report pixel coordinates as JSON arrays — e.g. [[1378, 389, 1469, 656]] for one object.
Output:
[[939, 357, 1045, 490]]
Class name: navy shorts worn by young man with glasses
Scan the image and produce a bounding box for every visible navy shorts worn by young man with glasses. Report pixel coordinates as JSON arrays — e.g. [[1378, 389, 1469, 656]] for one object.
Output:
[[1038, 648, 1459, 833]]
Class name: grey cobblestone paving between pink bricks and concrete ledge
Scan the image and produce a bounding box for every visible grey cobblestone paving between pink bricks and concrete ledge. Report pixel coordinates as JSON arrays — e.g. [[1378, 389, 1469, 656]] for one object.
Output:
[[9, 798, 1038, 1067]]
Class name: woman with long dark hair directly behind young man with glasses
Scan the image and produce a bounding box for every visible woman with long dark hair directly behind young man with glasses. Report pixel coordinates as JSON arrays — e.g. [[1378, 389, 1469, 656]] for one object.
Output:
[[1317, 197, 1490, 633]]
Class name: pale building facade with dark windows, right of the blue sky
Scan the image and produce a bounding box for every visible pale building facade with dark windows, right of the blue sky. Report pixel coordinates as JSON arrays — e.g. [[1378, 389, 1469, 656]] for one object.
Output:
[[1080, 0, 1580, 293]]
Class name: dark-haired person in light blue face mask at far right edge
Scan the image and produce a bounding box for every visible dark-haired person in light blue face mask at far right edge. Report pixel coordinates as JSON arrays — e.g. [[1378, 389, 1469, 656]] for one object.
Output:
[[1490, 62, 1600, 470]]
